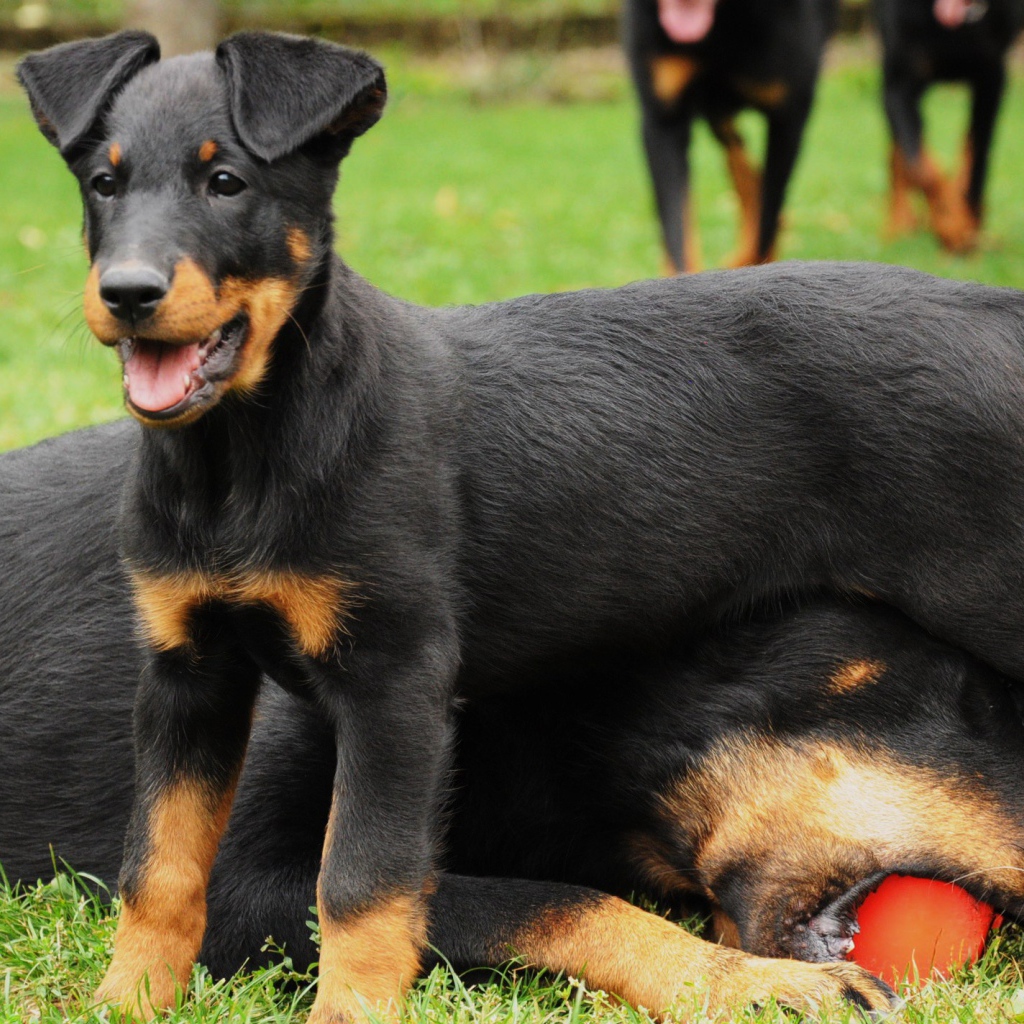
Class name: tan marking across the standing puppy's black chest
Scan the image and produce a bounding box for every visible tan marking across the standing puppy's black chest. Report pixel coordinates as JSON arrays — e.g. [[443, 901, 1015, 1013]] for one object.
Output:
[[131, 569, 355, 657]]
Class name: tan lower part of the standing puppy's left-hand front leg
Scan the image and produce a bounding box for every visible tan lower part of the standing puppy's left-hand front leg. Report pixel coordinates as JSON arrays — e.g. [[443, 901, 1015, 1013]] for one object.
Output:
[[95, 782, 233, 1020]]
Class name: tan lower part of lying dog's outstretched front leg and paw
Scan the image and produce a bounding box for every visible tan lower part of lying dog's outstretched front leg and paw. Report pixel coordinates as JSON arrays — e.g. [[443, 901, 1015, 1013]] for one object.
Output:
[[511, 896, 888, 1020]]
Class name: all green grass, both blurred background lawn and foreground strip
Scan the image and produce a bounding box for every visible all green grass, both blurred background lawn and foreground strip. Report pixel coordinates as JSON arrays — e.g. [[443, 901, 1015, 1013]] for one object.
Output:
[[6, 54, 1024, 1024]]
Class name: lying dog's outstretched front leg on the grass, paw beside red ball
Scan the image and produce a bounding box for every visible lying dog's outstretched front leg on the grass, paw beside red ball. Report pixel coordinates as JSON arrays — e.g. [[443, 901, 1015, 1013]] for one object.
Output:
[[430, 876, 893, 1020]]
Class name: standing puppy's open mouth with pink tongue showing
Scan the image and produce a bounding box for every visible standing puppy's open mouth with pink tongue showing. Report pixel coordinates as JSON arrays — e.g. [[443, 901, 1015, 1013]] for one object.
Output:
[[117, 313, 249, 420]]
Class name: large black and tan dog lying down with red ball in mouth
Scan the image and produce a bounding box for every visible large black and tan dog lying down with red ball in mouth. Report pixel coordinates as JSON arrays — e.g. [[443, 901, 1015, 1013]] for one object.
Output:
[[9, 424, 1024, 1012]]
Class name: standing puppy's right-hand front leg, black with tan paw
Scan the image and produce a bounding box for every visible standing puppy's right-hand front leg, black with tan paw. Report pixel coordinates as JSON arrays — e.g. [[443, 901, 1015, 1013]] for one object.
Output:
[[309, 622, 456, 1024]]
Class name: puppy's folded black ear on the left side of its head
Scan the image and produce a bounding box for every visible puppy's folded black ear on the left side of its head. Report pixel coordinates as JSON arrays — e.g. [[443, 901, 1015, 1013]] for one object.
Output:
[[17, 32, 160, 159]]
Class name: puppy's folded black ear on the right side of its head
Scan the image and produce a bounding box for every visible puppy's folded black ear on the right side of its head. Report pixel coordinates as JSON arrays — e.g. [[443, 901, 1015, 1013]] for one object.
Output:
[[217, 32, 387, 161]]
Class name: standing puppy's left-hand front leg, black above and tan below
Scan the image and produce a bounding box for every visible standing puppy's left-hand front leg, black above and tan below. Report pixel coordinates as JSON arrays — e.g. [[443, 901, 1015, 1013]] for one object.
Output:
[[96, 646, 258, 1017]]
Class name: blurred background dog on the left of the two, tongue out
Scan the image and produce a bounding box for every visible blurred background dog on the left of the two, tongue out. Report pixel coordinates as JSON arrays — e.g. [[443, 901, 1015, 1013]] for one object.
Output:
[[623, 0, 839, 271]]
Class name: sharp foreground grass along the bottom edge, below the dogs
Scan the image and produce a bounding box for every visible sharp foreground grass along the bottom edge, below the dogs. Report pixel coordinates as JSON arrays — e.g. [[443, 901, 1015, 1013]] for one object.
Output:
[[6, 874, 1024, 1024]]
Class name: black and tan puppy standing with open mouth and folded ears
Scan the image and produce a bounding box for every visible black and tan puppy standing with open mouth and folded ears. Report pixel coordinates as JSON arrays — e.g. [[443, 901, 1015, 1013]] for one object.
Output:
[[19, 33, 1024, 1022]]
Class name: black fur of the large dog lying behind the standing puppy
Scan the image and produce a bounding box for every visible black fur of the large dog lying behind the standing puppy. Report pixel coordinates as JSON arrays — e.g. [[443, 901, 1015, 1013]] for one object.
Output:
[[0, 424, 1024, 974]]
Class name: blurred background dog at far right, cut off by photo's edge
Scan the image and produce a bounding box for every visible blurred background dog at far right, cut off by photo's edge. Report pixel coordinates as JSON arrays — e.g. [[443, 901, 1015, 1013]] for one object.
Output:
[[874, 0, 1024, 252]]
